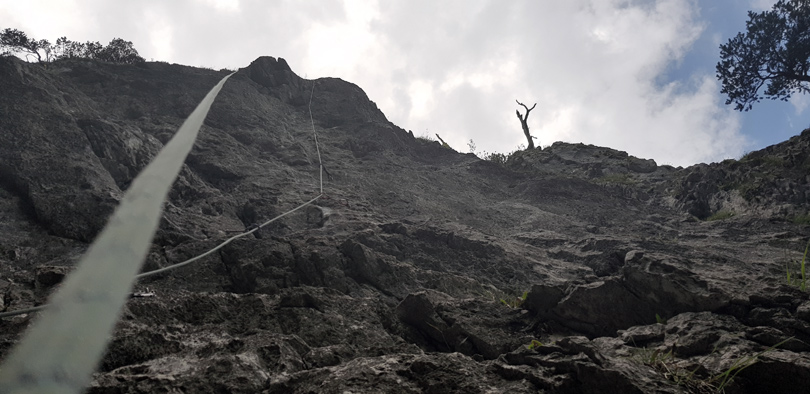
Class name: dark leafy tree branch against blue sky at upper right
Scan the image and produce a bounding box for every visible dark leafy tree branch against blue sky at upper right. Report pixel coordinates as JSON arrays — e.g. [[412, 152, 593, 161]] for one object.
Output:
[[717, 0, 810, 111]]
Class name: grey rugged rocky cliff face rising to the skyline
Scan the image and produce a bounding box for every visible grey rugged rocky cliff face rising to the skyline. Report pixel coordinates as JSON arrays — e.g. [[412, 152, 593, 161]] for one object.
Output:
[[0, 57, 810, 393]]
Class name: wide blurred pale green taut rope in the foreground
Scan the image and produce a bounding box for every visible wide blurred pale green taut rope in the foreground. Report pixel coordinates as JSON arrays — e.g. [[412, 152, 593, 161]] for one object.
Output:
[[0, 73, 233, 394]]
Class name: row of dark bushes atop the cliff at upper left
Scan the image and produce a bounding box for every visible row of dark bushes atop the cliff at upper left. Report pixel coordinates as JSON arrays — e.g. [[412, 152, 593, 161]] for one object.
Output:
[[0, 29, 144, 64]]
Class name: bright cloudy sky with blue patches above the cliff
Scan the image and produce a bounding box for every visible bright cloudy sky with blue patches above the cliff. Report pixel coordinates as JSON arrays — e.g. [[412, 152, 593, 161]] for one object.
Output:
[[0, 0, 810, 166]]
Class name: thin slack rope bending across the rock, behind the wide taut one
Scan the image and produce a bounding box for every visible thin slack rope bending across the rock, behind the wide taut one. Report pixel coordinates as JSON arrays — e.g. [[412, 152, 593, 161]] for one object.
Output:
[[0, 81, 323, 319]]
